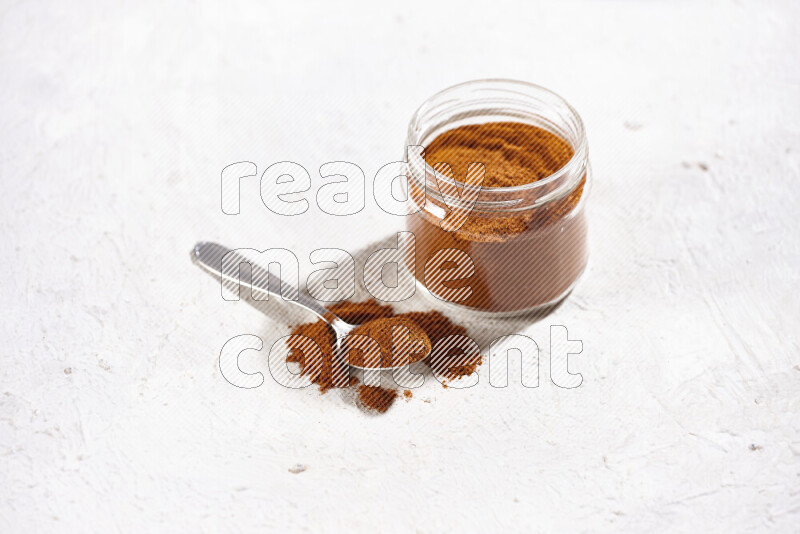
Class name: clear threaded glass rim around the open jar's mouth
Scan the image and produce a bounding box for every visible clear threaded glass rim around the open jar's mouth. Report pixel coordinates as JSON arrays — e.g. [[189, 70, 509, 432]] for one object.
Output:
[[406, 78, 588, 196]]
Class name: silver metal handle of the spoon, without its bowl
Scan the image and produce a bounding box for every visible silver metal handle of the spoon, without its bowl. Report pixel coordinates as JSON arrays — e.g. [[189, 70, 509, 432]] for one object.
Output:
[[191, 241, 341, 326]]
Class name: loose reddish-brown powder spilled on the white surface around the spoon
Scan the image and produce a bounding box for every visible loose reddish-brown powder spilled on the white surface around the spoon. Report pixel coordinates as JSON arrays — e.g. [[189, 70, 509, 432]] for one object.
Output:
[[287, 300, 481, 406]]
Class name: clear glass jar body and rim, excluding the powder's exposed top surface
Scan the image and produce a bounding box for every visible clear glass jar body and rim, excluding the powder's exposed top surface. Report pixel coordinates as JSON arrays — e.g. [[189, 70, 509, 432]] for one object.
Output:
[[406, 80, 591, 315]]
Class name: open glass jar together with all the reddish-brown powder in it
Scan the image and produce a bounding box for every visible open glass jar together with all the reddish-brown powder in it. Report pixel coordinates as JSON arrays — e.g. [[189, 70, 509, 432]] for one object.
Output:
[[406, 80, 591, 315]]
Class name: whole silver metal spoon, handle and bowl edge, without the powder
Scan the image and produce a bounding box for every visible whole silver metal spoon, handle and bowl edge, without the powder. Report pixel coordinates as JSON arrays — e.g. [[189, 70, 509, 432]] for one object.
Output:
[[191, 241, 424, 376]]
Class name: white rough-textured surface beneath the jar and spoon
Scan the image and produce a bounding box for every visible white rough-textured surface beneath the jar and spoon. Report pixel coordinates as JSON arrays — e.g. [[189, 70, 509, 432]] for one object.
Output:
[[0, 1, 800, 532]]
